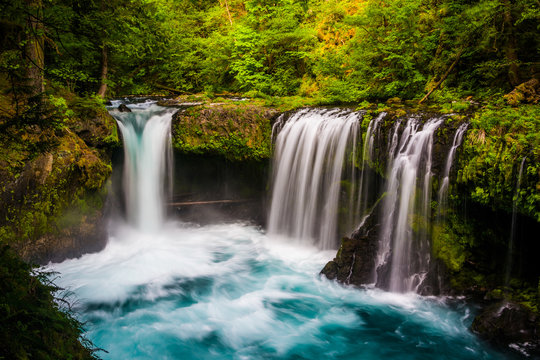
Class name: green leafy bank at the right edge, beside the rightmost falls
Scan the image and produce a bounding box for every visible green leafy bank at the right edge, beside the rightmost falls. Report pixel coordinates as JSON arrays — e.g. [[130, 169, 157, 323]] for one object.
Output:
[[458, 105, 540, 221]]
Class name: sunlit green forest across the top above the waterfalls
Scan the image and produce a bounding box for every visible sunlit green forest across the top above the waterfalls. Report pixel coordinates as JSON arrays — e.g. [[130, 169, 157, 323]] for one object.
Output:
[[0, 0, 540, 106]]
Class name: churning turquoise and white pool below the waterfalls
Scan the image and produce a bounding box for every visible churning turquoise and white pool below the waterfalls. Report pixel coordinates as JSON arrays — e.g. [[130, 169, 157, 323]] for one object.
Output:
[[49, 222, 507, 359]]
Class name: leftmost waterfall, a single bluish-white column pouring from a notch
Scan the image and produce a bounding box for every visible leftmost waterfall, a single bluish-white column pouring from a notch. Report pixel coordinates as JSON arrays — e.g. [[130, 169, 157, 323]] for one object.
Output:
[[111, 102, 176, 231]]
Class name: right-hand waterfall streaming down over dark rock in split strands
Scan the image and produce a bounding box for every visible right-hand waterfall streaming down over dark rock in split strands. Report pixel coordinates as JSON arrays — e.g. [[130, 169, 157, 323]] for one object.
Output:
[[377, 118, 443, 292]]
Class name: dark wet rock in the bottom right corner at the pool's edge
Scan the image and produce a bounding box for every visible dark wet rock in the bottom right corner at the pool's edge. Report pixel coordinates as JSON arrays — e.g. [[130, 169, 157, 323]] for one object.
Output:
[[471, 300, 540, 357]]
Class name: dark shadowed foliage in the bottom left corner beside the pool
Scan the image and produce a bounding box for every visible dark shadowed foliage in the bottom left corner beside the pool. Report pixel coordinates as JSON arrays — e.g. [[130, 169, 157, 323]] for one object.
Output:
[[0, 245, 97, 359]]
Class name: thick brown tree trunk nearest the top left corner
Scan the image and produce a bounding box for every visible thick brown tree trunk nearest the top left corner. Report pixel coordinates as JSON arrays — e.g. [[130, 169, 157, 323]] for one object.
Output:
[[24, 0, 45, 97]]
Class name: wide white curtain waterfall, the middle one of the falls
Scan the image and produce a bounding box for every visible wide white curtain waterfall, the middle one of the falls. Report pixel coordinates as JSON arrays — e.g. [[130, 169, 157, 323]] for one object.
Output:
[[268, 109, 361, 249]]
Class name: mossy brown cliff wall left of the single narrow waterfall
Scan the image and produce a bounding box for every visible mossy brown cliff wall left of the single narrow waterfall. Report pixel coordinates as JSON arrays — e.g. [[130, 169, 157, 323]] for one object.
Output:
[[0, 101, 118, 263]]
